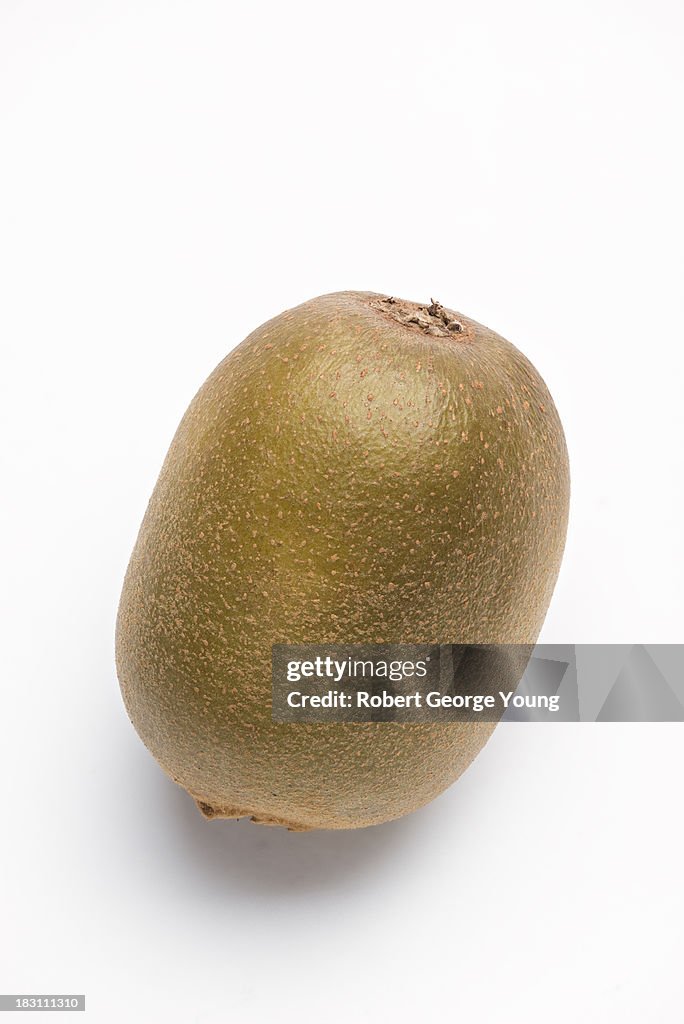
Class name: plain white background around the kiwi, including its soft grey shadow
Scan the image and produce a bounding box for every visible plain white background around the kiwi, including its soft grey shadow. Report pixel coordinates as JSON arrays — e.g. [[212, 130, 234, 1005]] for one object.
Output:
[[0, 0, 684, 1024]]
